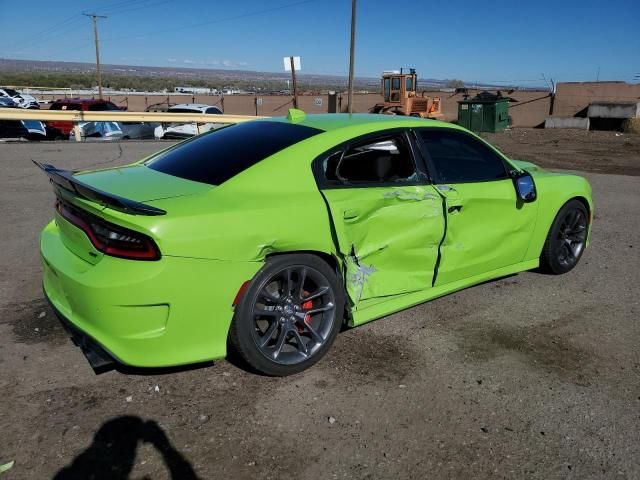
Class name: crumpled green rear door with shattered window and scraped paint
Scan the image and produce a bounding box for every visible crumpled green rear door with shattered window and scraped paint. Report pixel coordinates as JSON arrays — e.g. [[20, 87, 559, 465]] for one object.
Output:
[[321, 133, 444, 308]]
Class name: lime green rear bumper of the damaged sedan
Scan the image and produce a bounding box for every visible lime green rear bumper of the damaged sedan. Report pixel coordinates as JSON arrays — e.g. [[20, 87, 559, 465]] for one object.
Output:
[[40, 222, 262, 367]]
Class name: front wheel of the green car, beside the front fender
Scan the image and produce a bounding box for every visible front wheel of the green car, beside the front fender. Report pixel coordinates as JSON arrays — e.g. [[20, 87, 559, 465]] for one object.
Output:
[[540, 199, 590, 275]]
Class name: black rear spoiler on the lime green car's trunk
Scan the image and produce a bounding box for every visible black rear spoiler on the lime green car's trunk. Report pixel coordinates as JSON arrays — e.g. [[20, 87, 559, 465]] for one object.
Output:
[[32, 160, 167, 215]]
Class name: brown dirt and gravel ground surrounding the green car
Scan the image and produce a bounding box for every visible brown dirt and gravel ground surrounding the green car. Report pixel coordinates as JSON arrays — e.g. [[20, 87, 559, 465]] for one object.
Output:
[[0, 130, 640, 480]]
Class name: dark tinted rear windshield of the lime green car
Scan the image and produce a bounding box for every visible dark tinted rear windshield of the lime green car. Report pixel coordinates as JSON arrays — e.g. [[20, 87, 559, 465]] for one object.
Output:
[[147, 121, 322, 185]]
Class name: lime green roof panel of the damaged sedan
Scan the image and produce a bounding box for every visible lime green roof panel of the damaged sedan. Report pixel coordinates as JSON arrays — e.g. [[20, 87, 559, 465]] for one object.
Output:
[[265, 113, 456, 132]]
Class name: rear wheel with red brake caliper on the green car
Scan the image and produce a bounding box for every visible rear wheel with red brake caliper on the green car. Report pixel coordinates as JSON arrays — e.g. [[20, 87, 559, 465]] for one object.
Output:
[[228, 254, 344, 376]]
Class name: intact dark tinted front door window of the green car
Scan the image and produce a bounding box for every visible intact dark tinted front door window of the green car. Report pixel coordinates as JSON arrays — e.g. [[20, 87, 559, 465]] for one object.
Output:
[[419, 129, 508, 183]]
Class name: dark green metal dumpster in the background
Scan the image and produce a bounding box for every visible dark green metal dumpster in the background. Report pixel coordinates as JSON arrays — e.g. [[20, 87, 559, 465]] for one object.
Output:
[[458, 92, 511, 132]]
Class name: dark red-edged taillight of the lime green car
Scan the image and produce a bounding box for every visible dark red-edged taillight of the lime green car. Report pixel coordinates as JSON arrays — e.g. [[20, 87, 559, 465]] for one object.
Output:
[[56, 200, 160, 260]]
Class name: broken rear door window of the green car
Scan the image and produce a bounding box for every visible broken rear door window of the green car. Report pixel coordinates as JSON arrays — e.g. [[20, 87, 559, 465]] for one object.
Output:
[[322, 134, 418, 186]]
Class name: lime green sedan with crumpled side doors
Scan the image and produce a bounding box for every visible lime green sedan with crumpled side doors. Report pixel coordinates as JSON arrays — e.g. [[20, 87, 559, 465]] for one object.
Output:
[[39, 110, 593, 375]]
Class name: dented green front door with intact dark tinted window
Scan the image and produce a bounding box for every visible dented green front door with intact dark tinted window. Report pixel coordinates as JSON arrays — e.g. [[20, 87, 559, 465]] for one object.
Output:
[[418, 128, 538, 286]]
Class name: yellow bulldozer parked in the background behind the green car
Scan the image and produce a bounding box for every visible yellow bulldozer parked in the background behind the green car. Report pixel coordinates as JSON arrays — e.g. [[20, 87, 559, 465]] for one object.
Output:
[[370, 68, 442, 118]]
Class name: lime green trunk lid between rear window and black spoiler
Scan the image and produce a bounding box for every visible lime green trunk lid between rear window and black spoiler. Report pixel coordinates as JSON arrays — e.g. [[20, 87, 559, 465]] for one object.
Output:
[[74, 164, 214, 202]]
